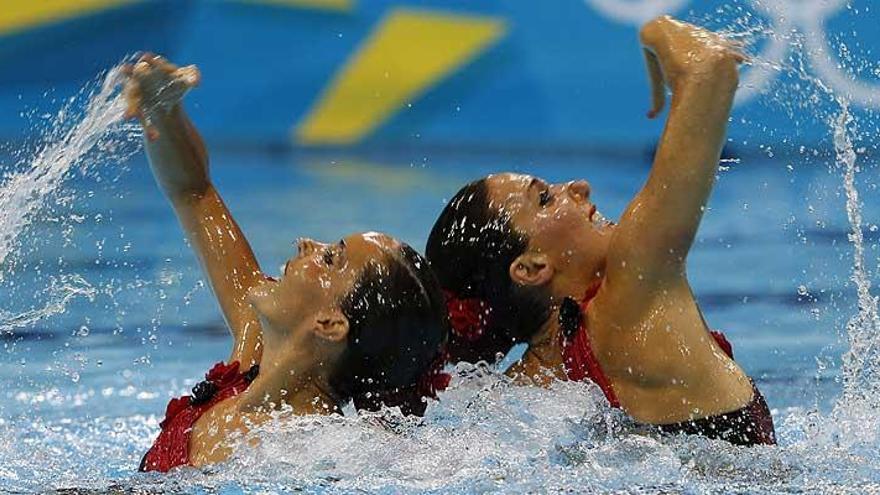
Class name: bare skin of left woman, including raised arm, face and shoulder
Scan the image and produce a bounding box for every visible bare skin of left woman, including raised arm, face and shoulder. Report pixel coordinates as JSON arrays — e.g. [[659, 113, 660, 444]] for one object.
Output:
[[125, 54, 410, 466]]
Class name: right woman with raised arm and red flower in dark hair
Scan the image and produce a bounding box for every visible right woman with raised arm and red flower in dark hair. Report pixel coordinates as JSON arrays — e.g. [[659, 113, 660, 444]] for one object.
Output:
[[426, 17, 775, 445]]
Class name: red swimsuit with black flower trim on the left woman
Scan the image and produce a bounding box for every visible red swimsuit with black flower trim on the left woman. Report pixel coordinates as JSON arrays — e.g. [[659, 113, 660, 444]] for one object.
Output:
[[138, 361, 259, 473]]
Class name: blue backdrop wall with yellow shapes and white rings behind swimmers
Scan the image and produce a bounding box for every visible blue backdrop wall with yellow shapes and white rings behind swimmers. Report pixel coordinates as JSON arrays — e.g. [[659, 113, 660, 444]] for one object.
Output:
[[0, 0, 880, 153]]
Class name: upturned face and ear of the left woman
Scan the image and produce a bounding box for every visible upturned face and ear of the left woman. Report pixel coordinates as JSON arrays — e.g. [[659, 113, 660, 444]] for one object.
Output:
[[248, 233, 399, 342]]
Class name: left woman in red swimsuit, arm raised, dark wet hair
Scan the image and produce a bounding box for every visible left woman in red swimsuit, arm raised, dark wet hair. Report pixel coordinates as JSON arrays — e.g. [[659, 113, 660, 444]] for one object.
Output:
[[126, 55, 447, 471]]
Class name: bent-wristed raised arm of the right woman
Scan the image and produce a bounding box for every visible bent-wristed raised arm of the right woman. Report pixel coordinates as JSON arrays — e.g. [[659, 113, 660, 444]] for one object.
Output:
[[608, 17, 743, 285]]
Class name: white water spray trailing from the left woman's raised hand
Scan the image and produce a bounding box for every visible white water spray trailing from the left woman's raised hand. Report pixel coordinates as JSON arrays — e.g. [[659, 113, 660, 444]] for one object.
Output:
[[0, 63, 140, 332]]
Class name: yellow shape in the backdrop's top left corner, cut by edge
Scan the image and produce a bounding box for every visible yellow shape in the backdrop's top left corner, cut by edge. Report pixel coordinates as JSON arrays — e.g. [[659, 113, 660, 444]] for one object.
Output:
[[0, 0, 133, 34]]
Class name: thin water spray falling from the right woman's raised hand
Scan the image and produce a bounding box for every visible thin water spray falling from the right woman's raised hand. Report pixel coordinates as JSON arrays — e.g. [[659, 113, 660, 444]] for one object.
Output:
[[704, 2, 880, 406]]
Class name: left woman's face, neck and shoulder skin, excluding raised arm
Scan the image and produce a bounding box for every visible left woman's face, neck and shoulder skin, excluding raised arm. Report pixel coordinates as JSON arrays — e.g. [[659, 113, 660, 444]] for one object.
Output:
[[190, 233, 400, 466]]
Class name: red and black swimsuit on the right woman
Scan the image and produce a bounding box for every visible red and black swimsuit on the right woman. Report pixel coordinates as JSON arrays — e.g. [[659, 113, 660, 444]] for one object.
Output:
[[560, 287, 776, 445]]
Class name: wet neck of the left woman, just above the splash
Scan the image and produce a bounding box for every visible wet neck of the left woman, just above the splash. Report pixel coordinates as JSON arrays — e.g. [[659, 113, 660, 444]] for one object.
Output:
[[236, 345, 338, 414]]
